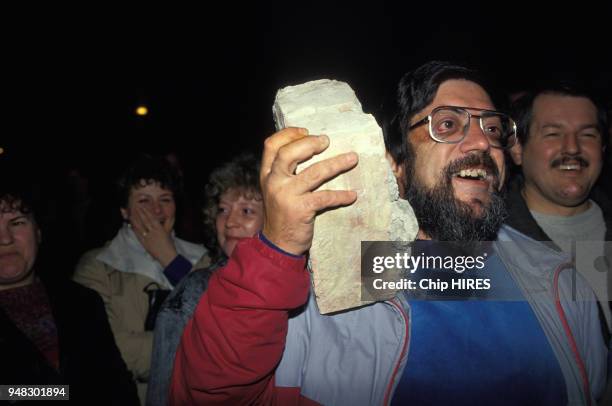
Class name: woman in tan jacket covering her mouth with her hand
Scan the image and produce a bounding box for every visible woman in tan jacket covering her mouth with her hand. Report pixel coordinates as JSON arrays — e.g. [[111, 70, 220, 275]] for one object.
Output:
[[74, 156, 208, 401]]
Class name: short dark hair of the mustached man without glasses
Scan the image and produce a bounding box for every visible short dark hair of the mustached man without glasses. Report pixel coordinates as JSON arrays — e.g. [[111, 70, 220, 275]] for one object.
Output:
[[511, 80, 608, 145]]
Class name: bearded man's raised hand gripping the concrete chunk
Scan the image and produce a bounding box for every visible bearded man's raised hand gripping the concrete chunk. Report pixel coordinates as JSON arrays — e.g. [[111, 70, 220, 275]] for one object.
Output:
[[260, 128, 358, 255]]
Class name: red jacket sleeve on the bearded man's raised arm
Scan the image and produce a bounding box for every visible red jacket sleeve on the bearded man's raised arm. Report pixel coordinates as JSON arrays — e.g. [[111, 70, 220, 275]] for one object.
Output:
[[170, 238, 310, 405]]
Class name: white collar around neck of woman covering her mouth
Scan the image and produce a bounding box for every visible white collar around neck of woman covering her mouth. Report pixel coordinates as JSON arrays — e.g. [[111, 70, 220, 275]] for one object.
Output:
[[96, 224, 206, 289]]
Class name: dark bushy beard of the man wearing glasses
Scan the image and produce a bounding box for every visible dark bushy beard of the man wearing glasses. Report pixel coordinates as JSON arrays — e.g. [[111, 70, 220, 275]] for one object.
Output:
[[405, 147, 507, 243]]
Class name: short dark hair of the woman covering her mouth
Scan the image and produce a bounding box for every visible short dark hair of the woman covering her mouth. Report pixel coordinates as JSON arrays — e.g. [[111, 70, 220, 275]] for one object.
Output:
[[117, 155, 182, 207]]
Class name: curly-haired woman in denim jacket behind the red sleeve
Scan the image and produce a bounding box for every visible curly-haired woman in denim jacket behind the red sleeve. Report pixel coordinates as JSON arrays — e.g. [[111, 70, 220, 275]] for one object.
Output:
[[147, 154, 264, 405]]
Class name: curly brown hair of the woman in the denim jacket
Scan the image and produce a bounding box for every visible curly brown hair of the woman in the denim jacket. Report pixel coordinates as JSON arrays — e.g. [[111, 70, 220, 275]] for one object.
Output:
[[202, 153, 261, 260]]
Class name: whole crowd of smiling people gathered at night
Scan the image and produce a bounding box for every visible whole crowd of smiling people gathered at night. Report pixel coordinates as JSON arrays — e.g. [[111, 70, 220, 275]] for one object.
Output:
[[0, 62, 612, 405]]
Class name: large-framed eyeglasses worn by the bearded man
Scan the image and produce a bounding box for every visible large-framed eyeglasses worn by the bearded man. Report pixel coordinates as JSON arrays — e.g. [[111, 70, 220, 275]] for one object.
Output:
[[409, 106, 516, 149]]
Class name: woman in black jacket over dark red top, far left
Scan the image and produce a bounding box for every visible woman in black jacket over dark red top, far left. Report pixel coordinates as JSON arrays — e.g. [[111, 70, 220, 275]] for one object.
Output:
[[0, 182, 138, 405]]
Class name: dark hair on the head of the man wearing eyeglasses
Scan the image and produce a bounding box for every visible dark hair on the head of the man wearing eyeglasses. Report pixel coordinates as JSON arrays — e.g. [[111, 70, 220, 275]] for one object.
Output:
[[381, 61, 494, 164]]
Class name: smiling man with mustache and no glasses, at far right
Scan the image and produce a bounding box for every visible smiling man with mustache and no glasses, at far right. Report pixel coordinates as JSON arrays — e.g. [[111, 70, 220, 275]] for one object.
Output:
[[507, 83, 612, 334]]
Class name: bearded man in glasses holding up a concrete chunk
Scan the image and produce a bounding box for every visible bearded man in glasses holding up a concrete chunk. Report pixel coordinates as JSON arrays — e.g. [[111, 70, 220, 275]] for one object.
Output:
[[170, 62, 607, 405]]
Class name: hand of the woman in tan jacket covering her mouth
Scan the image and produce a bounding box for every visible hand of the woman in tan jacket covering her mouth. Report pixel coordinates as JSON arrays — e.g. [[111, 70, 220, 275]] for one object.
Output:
[[130, 206, 178, 268]]
